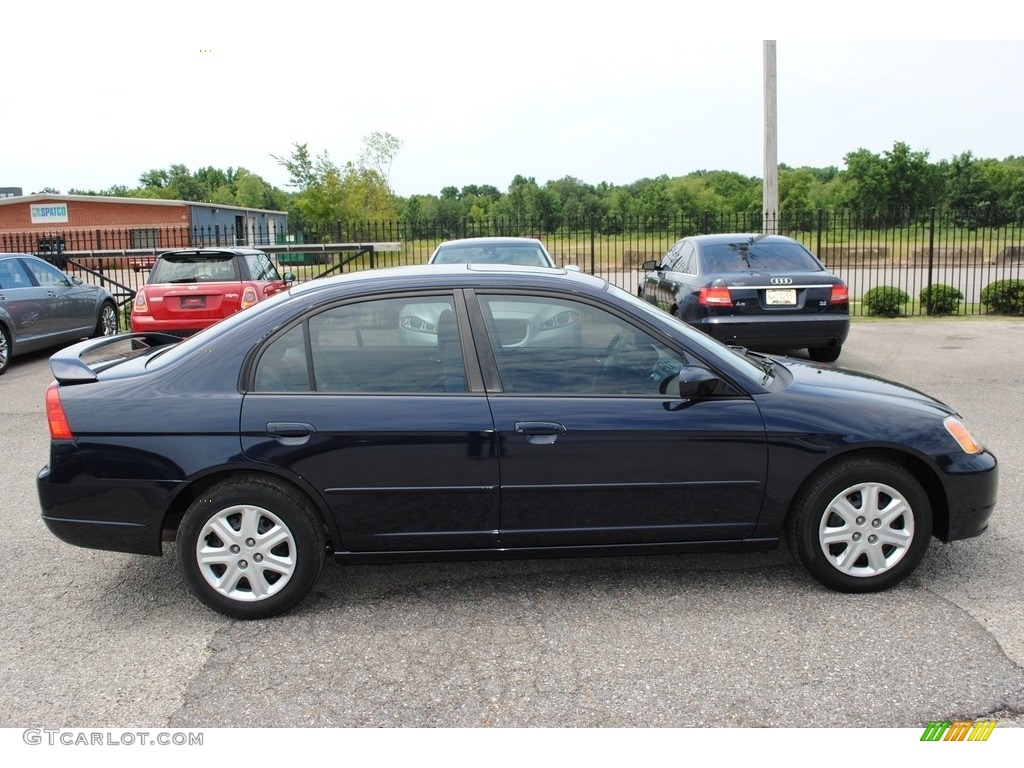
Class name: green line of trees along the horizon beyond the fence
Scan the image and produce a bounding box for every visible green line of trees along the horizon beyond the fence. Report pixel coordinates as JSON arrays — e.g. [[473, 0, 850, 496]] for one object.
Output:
[[58, 133, 1024, 236]]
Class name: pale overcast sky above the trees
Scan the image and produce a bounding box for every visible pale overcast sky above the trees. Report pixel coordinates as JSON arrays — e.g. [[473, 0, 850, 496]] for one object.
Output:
[[0, 0, 1024, 196]]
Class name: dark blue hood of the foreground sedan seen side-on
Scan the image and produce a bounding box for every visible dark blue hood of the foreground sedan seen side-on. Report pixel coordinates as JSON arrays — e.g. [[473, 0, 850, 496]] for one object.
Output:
[[776, 357, 956, 416]]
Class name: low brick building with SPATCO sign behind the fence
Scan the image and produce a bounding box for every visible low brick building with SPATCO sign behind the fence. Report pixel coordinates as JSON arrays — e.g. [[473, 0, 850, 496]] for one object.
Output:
[[0, 195, 288, 255]]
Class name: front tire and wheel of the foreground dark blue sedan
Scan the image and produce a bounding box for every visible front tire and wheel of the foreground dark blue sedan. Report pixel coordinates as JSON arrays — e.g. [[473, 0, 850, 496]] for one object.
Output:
[[786, 457, 932, 592]]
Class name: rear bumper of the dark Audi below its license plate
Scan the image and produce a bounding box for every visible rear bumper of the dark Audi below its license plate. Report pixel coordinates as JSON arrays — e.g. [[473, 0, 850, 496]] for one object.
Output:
[[694, 313, 850, 351]]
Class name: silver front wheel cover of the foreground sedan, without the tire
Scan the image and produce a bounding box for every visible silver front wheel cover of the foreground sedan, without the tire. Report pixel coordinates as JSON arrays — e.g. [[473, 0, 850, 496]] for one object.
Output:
[[818, 482, 914, 578]]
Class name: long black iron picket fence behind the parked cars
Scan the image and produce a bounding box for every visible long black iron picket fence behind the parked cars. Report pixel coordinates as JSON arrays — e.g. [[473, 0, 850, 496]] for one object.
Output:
[[14, 210, 1024, 314]]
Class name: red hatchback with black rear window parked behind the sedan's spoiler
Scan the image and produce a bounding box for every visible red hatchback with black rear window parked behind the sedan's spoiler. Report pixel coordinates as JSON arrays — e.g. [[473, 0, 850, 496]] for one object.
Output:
[[131, 248, 295, 336]]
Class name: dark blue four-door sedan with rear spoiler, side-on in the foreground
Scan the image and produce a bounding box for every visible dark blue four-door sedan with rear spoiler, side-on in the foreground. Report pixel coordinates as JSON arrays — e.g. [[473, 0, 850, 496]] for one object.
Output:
[[38, 264, 997, 618]]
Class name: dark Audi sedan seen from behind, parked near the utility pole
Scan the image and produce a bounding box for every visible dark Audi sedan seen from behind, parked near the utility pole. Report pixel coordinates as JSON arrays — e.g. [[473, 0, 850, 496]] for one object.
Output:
[[640, 234, 850, 362]]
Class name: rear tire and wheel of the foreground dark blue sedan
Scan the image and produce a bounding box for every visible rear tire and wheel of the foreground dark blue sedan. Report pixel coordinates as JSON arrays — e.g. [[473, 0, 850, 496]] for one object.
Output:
[[178, 475, 327, 618]]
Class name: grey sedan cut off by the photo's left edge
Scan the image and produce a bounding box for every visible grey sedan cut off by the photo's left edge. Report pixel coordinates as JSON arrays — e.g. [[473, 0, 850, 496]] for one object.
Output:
[[0, 253, 118, 374]]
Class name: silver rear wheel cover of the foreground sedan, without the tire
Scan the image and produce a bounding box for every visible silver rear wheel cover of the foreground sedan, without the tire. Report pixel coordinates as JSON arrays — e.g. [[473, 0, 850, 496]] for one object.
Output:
[[196, 505, 296, 602]]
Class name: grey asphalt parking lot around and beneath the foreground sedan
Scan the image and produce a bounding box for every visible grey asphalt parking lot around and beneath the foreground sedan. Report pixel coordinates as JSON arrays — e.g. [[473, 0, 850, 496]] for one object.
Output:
[[0, 318, 1024, 728]]
